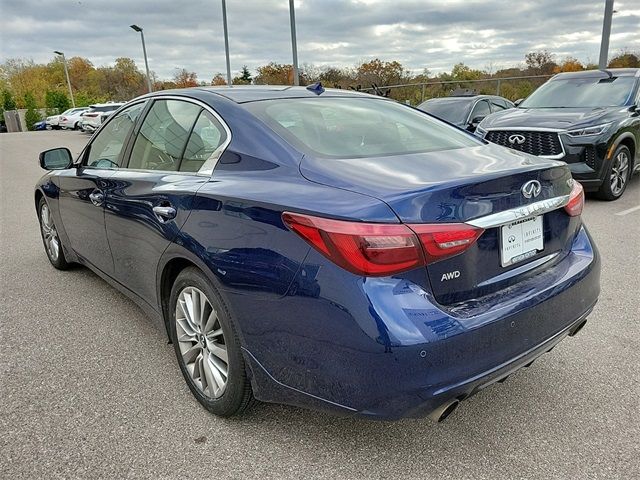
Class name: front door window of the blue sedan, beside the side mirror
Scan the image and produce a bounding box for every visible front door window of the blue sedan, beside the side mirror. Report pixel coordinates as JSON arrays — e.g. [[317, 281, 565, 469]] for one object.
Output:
[[85, 102, 145, 168]]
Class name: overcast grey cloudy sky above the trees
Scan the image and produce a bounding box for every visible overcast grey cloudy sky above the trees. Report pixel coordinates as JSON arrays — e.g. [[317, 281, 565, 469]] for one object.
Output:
[[0, 0, 640, 81]]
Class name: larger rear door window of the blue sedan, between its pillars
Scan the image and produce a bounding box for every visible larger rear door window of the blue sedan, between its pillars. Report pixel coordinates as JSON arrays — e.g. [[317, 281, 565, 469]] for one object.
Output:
[[128, 100, 202, 171]]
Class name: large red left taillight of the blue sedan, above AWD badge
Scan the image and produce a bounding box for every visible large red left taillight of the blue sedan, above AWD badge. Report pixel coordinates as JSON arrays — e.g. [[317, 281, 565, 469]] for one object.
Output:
[[282, 212, 483, 276]]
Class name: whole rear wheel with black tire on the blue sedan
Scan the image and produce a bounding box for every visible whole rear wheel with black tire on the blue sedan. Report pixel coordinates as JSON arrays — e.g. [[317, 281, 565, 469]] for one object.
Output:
[[169, 267, 253, 417]]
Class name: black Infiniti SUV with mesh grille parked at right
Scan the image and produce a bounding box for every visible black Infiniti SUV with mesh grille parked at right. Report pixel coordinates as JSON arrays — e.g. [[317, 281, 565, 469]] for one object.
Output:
[[476, 68, 640, 200]]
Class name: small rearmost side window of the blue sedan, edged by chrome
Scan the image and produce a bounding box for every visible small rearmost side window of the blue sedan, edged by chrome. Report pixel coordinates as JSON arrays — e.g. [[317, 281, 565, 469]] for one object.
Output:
[[179, 110, 227, 172]]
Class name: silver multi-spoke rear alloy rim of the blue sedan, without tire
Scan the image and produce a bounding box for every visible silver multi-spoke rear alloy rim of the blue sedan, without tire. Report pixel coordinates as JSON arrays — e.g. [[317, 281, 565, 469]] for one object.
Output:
[[175, 287, 229, 398]]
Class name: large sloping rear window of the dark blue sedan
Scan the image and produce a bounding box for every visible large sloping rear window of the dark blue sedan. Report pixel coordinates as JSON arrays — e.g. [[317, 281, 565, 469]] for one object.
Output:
[[244, 97, 481, 158]]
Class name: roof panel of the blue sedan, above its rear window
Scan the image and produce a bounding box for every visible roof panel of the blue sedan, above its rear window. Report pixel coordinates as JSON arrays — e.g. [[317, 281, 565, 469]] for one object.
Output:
[[192, 85, 375, 103]]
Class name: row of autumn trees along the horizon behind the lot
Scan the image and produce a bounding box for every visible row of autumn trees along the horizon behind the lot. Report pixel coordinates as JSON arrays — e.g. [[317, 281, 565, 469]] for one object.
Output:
[[0, 50, 640, 128]]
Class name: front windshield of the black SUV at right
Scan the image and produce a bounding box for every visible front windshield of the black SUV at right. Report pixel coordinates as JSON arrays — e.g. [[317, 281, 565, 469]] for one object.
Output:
[[519, 77, 636, 108]]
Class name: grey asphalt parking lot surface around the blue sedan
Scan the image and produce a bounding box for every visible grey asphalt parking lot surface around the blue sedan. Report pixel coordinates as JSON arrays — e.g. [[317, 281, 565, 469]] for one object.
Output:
[[0, 131, 640, 479]]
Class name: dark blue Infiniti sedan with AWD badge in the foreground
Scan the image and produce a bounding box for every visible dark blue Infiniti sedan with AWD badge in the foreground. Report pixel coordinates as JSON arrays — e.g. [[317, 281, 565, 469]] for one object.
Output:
[[35, 85, 600, 420]]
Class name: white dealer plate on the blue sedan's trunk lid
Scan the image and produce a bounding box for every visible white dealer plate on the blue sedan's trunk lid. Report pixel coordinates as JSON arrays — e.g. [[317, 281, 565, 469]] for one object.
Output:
[[500, 215, 544, 267]]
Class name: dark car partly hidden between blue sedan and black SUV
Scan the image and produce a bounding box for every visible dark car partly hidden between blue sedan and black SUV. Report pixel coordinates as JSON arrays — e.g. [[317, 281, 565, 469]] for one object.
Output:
[[418, 94, 515, 132]]
